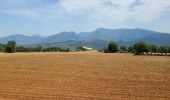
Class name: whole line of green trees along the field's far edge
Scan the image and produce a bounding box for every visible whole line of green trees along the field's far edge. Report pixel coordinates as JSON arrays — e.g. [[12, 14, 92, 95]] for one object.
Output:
[[0, 41, 170, 55]]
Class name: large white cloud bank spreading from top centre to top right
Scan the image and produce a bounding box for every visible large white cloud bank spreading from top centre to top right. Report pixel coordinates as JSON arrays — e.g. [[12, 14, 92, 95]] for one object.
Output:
[[55, 0, 170, 22]]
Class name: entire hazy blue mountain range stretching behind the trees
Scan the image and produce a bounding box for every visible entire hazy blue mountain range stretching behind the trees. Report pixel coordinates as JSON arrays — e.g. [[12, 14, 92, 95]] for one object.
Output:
[[0, 28, 170, 48]]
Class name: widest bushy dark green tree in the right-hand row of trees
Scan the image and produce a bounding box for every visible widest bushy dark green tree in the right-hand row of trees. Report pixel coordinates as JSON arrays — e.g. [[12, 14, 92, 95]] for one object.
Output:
[[133, 42, 149, 55]]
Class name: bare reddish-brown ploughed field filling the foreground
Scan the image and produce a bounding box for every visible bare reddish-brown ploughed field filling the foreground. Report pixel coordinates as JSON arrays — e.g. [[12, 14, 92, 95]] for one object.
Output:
[[0, 52, 170, 100]]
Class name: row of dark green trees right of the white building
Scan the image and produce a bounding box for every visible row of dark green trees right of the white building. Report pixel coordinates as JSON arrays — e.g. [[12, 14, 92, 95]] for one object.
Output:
[[104, 42, 170, 55]]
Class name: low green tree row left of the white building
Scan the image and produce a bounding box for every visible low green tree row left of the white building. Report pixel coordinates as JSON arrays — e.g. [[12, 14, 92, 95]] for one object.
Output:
[[0, 41, 70, 53]]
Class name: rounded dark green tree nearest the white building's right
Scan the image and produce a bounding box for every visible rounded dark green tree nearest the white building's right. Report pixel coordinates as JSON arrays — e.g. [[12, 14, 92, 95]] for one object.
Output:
[[107, 42, 119, 53]]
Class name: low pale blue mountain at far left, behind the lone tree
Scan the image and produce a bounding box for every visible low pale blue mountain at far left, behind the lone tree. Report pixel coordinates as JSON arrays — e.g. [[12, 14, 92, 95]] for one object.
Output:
[[0, 34, 44, 44]]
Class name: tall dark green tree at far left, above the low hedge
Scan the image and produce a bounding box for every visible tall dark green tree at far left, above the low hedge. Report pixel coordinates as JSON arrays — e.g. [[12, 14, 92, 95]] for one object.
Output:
[[5, 41, 16, 53]]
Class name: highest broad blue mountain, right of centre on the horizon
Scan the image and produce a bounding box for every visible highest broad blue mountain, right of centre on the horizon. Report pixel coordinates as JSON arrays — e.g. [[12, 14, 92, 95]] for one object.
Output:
[[77, 28, 158, 41]]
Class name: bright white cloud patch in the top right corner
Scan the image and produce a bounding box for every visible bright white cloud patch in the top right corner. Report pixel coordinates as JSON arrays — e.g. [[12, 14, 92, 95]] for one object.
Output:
[[131, 0, 170, 21]]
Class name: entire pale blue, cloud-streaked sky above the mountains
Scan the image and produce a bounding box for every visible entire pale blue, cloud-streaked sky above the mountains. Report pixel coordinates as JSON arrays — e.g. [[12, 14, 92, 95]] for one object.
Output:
[[0, 0, 170, 37]]
